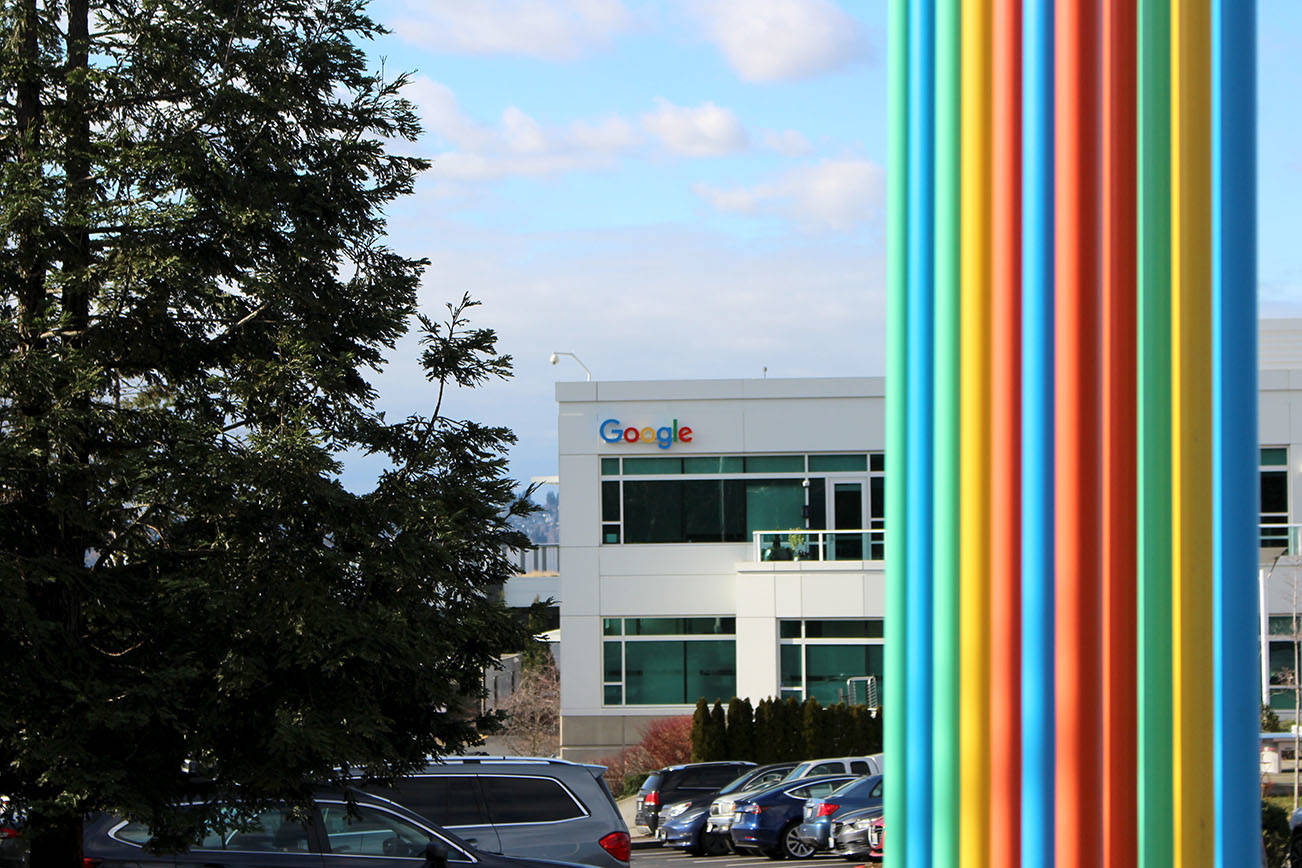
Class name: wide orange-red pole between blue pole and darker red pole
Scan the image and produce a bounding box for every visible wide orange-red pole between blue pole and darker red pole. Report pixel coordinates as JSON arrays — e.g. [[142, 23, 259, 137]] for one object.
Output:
[[1053, 0, 1103, 868]]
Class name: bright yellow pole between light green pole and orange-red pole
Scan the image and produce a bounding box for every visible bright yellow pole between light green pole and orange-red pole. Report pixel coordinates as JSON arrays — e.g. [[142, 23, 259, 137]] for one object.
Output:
[[958, 0, 992, 868]]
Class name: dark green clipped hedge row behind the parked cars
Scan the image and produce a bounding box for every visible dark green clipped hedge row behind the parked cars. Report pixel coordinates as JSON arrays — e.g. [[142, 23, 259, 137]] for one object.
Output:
[[691, 696, 881, 763]]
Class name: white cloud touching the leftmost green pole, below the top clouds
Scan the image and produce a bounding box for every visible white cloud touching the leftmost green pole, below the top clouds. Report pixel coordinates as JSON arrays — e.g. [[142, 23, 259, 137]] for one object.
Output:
[[693, 159, 884, 230]]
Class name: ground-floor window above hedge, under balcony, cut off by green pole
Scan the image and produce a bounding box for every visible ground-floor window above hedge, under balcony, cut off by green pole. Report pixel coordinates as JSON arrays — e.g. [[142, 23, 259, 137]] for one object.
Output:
[[777, 618, 884, 702]]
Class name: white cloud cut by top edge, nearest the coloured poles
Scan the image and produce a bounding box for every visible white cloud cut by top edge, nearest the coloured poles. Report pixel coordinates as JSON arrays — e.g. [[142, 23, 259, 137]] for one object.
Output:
[[687, 0, 868, 82]]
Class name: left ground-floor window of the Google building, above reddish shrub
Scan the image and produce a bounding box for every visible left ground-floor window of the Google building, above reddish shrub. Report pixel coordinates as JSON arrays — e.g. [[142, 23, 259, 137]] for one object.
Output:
[[602, 617, 737, 705]]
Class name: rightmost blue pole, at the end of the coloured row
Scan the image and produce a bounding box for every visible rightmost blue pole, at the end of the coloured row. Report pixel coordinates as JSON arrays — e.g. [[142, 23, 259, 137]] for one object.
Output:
[[1212, 0, 1262, 868]]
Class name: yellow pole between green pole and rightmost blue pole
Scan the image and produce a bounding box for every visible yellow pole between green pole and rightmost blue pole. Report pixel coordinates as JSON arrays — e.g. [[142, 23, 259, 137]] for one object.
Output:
[[1170, 0, 1215, 868]]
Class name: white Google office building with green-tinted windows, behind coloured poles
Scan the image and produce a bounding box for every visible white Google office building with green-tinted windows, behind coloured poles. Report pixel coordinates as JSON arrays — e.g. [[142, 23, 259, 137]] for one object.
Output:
[[556, 359, 1302, 760]]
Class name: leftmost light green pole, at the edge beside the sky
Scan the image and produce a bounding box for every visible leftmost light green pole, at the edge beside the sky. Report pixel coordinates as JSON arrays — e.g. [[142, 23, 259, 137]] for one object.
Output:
[[883, 0, 909, 864]]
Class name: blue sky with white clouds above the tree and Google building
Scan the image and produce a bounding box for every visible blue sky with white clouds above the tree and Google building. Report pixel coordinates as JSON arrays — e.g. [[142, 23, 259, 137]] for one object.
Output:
[[345, 0, 1302, 487]]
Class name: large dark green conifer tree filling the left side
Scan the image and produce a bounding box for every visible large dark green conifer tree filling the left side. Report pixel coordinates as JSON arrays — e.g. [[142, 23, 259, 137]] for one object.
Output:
[[0, 0, 527, 863]]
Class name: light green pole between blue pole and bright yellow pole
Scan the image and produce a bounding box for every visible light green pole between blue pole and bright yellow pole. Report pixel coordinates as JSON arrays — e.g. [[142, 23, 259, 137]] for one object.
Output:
[[932, 0, 962, 865]]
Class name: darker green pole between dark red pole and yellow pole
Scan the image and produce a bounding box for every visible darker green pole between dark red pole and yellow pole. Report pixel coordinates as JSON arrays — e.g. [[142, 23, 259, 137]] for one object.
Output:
[[1138, 0, 1182, 865]]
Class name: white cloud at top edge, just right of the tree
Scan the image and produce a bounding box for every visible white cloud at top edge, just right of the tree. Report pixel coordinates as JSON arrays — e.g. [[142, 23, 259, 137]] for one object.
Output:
[[391, 0, 631, 60]]
